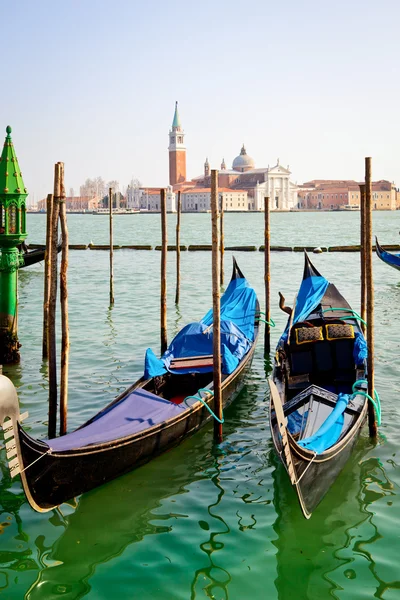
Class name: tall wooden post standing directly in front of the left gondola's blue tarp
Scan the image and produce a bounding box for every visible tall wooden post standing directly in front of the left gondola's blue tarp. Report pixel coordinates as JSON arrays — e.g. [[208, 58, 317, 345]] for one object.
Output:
[[211, 169, 222, 444]]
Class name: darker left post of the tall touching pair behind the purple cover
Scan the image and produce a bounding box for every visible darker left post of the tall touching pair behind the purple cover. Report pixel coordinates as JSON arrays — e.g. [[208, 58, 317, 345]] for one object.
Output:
[[47, 163, 61, 438]]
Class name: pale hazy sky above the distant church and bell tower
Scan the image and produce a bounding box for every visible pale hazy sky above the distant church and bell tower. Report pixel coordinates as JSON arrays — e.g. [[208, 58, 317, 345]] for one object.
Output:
[[0, 0, 400, 201]]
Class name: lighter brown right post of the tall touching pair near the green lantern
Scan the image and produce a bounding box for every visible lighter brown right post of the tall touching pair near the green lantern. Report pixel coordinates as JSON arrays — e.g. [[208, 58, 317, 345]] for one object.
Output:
[[59, 163, 69, 435]]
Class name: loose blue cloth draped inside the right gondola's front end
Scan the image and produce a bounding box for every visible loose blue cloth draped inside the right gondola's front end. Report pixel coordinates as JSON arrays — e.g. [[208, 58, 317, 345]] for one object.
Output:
[[297, 394, 350, 454]]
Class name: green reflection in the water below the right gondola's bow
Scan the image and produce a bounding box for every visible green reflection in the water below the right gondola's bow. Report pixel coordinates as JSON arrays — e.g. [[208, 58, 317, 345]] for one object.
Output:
[[272, 437, 400, 600]]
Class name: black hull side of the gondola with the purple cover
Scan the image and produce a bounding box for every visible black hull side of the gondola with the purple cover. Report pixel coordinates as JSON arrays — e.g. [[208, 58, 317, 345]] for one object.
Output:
[[3, 338, 254, 512]]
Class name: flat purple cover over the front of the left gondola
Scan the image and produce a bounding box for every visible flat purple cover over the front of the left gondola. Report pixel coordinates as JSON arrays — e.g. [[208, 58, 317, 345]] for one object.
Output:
[[47, 389, 187, 452]]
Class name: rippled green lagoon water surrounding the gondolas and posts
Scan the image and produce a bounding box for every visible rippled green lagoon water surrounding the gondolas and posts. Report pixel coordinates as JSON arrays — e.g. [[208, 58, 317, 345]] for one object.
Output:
[[0, 213, 400, 600]]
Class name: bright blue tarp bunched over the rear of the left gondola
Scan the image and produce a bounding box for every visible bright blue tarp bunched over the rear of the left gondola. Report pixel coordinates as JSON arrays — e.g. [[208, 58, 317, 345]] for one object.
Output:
[[144, 277, 257, 379]]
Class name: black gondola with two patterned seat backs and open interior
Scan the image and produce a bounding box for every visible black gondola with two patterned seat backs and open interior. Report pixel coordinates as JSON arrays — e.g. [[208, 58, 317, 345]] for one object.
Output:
[[269, 254, 368, 518]]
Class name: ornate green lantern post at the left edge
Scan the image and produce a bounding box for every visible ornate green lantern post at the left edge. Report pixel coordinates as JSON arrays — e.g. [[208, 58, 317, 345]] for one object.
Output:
[[0, 126, 28, 364]]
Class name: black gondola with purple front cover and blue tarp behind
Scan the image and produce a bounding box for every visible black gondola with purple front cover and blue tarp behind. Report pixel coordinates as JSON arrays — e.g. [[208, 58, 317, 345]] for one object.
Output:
[[0, 261, 259, 512]]
